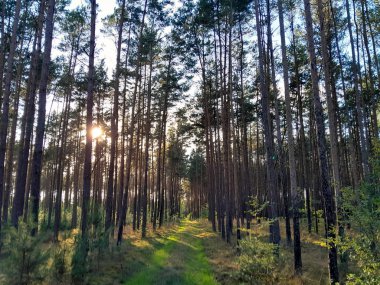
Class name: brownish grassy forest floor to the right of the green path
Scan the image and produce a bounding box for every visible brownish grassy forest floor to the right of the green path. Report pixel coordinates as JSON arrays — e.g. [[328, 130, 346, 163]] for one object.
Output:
[[200, 216, 329, 285]]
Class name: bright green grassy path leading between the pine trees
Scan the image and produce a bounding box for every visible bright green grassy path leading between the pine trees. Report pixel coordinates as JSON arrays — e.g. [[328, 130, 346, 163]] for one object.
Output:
[[124, 219, 218, 285]]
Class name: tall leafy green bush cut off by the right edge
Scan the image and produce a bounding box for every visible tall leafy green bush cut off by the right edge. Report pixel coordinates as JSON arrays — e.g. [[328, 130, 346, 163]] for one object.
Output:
[[339, 142, 380, 284]]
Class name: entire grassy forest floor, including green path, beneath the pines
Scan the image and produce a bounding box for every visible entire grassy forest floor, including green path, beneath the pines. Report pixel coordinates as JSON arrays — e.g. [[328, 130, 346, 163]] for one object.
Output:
[[0, 218, 328, 285]]
